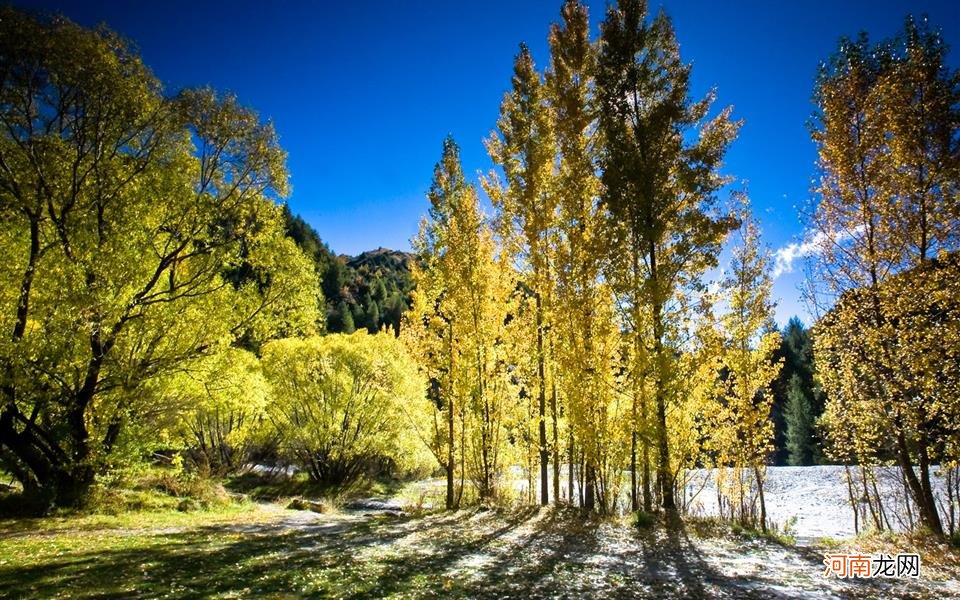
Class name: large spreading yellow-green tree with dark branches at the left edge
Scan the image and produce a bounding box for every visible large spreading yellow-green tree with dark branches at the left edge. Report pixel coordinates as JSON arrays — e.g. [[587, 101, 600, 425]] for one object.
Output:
[[0, 8, 319, 510]]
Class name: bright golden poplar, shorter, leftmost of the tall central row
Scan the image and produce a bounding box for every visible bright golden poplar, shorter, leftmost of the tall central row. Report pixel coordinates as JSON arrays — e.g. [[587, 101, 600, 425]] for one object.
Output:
[[403, 138, 516, 508]]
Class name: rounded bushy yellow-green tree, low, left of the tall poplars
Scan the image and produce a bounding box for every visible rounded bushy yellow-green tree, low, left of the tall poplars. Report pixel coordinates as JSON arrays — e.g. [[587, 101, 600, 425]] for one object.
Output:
[[262, 331, 435, 487]]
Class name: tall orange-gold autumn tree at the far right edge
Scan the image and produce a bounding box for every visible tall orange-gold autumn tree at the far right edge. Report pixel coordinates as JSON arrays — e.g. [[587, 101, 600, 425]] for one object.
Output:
[[811, 19, 960, 535]]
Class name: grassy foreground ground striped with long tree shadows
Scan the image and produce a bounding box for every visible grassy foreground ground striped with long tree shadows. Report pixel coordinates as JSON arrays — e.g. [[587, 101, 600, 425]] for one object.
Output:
[[0, 503, 945, 598]]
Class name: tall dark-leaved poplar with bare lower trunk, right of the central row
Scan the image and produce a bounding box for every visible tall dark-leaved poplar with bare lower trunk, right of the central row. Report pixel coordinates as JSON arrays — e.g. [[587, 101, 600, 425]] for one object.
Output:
[[596, 0, 738, 510]]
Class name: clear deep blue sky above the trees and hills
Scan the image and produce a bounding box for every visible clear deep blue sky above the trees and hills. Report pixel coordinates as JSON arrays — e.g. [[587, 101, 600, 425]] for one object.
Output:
[[14, 0, 960, 324]]
